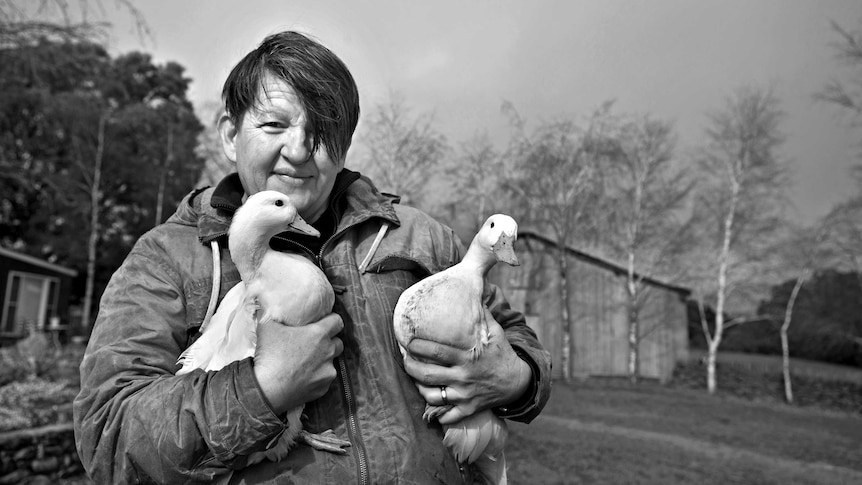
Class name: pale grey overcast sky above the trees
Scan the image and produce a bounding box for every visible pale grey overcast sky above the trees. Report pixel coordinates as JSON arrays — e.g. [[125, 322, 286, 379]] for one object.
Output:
[[96, 0, 862, 223]]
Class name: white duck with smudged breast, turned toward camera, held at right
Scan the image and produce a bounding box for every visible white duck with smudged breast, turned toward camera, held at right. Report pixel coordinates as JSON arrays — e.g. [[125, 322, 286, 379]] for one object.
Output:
[[393, 214, 518, 484]]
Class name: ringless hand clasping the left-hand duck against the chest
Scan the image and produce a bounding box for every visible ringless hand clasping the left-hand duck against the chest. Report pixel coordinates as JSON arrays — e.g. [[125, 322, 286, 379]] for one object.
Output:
[[254, 313, 344, 414]]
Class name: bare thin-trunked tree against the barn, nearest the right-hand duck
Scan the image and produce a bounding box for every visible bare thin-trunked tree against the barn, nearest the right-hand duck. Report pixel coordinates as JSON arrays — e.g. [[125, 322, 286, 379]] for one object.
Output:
[[503, 103, 611, 381]]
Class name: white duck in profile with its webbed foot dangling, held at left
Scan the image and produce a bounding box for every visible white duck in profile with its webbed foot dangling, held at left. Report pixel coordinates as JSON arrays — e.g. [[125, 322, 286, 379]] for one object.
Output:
[[177, 190, 350, 463]]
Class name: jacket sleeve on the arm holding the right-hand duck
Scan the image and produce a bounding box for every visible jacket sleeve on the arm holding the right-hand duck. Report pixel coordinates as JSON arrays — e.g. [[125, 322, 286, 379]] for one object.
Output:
[[450, 230, 551, 423]]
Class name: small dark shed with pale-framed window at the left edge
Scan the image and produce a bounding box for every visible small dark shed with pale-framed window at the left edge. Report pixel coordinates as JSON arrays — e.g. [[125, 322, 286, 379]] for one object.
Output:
[[0, 248, 77, 344]]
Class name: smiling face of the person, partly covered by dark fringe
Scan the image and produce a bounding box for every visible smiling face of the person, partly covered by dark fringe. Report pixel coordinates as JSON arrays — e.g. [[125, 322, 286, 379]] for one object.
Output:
[[219, 74, 344, 223]]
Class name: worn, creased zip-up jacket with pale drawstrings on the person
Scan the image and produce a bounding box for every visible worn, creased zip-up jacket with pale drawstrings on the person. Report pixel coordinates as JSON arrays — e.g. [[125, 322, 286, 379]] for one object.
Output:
[[73, 170, 550, 484]]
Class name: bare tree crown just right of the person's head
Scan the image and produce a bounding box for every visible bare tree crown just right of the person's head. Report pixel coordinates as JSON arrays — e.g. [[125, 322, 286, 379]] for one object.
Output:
[[357, 95, 449, 207]]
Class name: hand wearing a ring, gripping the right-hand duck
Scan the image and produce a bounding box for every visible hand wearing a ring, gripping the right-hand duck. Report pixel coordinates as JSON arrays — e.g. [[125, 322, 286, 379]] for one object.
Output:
[[404, 311, 532, 424]]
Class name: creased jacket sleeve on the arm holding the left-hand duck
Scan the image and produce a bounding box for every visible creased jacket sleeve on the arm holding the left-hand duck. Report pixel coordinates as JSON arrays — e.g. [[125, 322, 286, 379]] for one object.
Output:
[[73, 236, 285, 483]]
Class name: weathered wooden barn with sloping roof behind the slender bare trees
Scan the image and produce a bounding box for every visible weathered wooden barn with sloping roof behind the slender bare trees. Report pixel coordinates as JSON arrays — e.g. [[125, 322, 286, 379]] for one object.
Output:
[[490, 232, 690, 382]]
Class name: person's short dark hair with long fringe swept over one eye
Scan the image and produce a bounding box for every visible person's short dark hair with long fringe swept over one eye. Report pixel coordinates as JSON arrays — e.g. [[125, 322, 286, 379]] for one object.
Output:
[[222, 31, 359, 160]]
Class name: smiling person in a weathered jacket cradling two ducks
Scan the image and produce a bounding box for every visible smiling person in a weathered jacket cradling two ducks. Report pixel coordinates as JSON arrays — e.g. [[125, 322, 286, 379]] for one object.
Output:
[[73, 31, 550, 484]]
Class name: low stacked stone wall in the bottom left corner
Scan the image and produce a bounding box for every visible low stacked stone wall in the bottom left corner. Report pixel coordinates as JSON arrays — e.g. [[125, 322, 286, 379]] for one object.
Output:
[[0, 423, 84, 485]]
